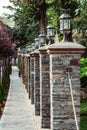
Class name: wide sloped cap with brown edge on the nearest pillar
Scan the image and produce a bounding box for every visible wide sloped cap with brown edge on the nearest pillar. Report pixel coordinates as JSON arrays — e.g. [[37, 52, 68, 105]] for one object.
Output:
[[47, 42, 86, 54]]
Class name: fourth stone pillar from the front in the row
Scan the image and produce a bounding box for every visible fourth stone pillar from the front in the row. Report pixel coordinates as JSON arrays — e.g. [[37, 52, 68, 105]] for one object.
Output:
[[30, 53, 34, 104]]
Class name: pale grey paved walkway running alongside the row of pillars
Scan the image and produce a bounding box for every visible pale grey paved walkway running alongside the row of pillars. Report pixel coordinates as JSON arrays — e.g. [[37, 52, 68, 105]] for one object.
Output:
[[0, 66, 41, 130]]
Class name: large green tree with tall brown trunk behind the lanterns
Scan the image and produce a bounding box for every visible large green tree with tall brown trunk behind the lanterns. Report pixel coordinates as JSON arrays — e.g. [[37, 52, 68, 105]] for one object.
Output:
[[8, 0, 78, 46]]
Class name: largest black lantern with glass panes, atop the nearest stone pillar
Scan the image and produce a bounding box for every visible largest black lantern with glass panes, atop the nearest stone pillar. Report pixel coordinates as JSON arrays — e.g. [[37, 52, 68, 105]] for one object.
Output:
[[59, 14, 71, 41]]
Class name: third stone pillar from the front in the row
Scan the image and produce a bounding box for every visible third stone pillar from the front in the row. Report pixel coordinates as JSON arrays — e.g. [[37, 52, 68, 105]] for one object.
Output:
[[33, 51, 40, 116]]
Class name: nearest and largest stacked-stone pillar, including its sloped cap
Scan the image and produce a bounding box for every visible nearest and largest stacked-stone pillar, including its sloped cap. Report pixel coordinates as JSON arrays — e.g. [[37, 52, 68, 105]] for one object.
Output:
[[48, 42, 85, 130]]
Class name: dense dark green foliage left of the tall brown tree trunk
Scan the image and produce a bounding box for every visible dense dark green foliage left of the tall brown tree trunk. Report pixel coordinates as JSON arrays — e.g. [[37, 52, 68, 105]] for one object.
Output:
[[12, 4, 39, 47]]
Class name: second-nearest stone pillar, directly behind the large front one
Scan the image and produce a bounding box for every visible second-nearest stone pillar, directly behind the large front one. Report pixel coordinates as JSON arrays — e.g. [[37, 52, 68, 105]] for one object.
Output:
[[39, 47, 50, 128]]
